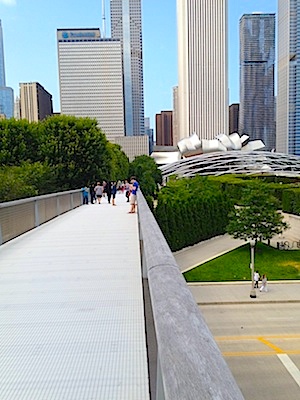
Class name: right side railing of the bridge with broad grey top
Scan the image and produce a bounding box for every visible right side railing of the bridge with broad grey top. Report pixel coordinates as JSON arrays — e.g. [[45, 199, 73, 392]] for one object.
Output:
[[138, 193, 244, 400]]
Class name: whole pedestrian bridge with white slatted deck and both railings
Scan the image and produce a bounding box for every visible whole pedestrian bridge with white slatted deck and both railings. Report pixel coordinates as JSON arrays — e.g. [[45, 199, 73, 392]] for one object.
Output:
[[0, 190, 243, 400]]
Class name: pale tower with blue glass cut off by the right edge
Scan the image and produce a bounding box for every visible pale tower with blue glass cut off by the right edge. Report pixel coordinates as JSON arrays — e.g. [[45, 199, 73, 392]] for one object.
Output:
[[276, 0, 300, 156]]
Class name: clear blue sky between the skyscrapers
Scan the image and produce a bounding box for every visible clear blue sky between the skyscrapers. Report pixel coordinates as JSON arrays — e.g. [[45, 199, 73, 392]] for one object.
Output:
[[0, 0, 277, 128]]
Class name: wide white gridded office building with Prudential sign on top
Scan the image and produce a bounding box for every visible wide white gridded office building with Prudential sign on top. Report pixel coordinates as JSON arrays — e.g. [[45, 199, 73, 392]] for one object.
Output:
[[57, 29, 124, 139]]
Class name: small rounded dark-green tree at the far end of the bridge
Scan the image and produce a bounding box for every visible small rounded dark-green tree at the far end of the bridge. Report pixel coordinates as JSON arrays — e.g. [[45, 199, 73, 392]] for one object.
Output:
[[129, 155, 162, 196]]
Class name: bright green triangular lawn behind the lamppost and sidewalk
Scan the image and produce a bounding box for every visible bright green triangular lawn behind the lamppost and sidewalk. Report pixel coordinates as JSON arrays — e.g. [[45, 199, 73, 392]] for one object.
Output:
[[183, 243, 300, 282]]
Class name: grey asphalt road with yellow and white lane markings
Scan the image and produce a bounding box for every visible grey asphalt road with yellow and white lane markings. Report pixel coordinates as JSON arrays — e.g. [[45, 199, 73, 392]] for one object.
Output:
[[200, 303, 300, 400]]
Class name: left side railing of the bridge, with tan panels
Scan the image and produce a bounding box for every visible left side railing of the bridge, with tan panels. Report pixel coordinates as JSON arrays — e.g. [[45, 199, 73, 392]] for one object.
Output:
[[0, 190, 82, 245]]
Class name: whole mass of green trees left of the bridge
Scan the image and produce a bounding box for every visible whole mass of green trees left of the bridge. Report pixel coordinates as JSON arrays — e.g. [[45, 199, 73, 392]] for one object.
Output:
[[0, 115, 129, 201]]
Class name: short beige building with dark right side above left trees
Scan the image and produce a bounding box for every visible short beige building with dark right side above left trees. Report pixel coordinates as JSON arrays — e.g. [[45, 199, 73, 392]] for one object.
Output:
[[20, 82, 53, 122]]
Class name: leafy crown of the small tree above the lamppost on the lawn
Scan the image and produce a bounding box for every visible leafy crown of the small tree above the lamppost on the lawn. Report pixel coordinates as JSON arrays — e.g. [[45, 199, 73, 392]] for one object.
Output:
[[227, 183, 288, 242]]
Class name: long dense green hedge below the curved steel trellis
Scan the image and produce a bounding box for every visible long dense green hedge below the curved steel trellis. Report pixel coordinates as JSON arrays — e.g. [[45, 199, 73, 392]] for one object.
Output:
[[154, 175, 300, 251]]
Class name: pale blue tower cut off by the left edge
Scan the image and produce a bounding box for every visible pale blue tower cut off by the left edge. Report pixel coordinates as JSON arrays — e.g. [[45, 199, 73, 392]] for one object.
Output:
[[0, 20, 14, 118]]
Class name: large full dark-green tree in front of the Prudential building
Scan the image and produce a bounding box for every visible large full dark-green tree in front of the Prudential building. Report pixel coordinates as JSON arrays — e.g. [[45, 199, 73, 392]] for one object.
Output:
[[42, 115, 112, 189]]
